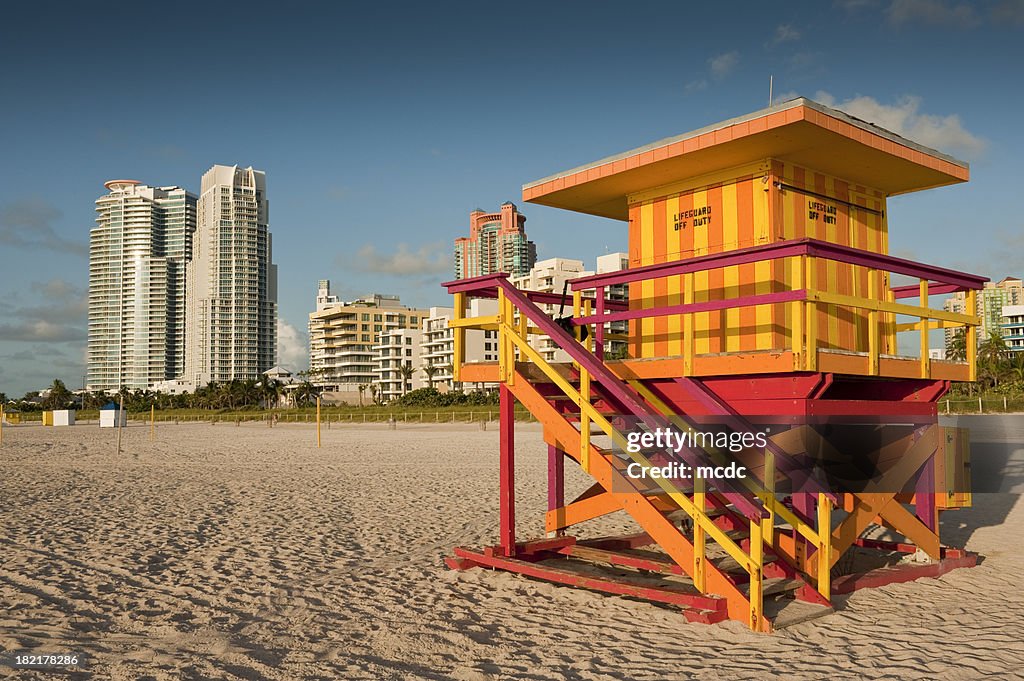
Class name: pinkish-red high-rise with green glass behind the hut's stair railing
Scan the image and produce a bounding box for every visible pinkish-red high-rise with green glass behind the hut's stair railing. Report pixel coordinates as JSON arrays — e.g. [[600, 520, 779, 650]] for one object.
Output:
[[455, 202, 537, 279]]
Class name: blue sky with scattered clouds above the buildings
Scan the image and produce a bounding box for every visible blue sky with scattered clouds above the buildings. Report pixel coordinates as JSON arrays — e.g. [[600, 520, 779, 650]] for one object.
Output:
[[0, 0, 1024, 394]]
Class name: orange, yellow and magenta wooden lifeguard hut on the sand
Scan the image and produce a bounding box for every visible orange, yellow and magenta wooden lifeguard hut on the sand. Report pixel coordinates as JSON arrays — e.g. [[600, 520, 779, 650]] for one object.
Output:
[[444, 98, 986, 632]]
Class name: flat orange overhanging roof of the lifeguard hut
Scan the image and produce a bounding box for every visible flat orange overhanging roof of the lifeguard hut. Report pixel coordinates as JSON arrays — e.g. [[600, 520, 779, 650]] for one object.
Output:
[[522, 97, 970, 220]]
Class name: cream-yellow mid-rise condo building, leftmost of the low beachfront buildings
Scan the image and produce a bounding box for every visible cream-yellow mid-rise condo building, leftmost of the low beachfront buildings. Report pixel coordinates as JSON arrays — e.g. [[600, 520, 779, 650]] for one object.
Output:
[[309, 283, 427, 392]]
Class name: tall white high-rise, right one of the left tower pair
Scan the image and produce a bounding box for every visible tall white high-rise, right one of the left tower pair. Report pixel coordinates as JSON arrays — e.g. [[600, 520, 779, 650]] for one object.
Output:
[[183, 166, 278, 386]]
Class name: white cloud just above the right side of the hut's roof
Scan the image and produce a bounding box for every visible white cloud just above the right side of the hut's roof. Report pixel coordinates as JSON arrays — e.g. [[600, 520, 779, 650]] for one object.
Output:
[[814, 91, 986, 158]]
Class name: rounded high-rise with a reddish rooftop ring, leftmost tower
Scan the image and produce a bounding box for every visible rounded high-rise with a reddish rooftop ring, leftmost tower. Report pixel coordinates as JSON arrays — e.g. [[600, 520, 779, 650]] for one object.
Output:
[[86, 180, 196, 390]]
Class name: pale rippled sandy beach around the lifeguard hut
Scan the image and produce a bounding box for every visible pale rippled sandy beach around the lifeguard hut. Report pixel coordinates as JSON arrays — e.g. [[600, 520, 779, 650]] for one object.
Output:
[[0, 424, 1024, 681]]
